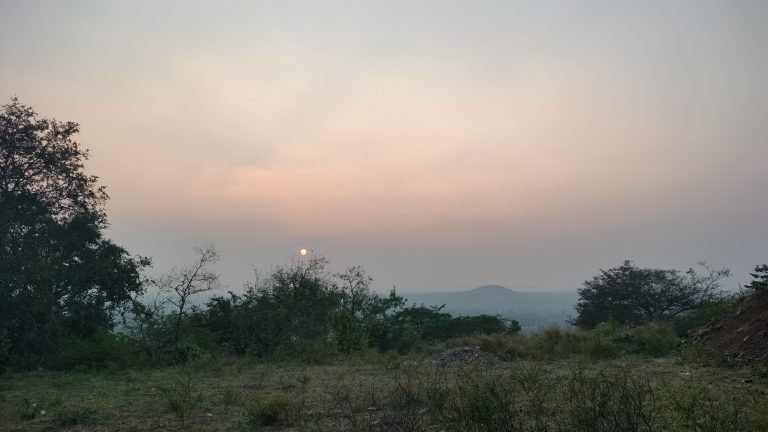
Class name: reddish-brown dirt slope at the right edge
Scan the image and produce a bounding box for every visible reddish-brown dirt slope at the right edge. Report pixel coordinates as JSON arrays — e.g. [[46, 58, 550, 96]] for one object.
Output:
[[692, 290, 768, 365]]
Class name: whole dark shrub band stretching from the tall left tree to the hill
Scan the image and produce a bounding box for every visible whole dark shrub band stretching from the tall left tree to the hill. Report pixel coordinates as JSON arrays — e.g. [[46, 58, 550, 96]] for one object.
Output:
[[15, 253, 520, 369]]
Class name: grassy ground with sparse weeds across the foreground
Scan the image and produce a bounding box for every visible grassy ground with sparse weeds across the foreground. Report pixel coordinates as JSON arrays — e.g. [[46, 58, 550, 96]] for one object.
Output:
[[0, 356, 768, 431]]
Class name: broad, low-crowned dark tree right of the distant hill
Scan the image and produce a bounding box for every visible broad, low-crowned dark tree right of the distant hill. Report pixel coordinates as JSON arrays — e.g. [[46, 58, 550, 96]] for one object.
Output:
[[573, 261, 730, 328]]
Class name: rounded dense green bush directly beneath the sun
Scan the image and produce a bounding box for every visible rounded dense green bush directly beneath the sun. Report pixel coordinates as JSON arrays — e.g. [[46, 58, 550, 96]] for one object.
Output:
[[194, 257, 412, 362]]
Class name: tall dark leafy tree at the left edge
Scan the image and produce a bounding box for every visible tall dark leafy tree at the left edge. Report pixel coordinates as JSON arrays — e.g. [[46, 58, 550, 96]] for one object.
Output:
[[0, 98, 149, 366]]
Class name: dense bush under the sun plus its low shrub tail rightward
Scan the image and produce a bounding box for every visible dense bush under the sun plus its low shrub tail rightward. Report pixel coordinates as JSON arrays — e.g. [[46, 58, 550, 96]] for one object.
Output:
[[192, 258, 520, 361]]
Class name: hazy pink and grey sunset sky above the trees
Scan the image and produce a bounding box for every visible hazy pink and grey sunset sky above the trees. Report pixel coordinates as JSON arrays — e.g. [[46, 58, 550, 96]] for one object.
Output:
[[0, 0, 768, 292]]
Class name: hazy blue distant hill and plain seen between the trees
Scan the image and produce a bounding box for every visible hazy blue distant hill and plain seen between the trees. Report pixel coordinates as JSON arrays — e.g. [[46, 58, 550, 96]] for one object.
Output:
[[401, 285, 579, 332]]
